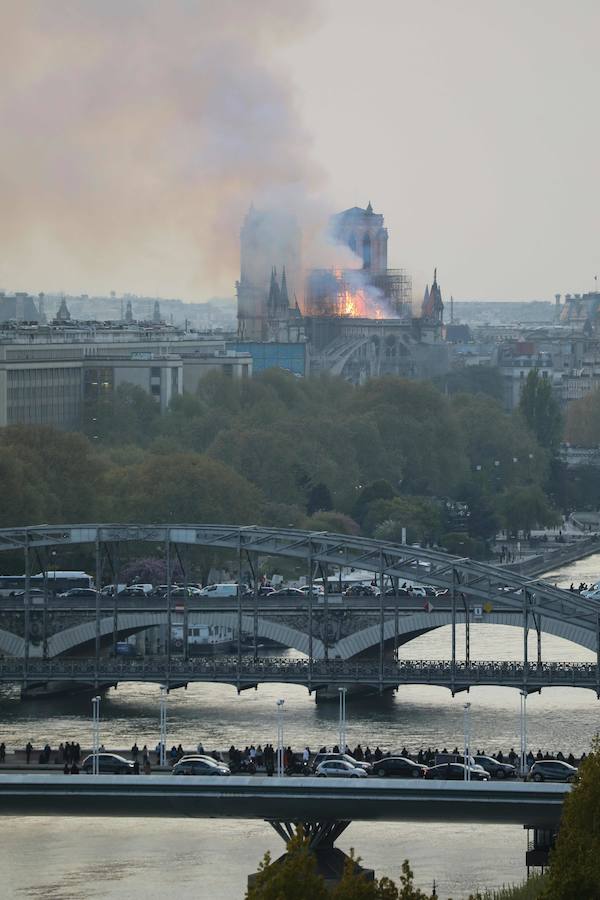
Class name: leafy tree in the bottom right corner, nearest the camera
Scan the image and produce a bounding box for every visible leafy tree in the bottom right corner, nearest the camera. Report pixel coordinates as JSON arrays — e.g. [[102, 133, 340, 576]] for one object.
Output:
[[542, 736, 600, 900]]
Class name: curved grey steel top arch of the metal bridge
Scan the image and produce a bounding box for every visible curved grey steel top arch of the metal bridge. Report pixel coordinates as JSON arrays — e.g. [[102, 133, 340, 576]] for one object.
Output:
[[0, 524, 600, 650]]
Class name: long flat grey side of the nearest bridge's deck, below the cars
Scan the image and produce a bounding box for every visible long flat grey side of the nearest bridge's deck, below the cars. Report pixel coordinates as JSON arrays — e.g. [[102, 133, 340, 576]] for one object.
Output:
[[0, 775, 570, 828]]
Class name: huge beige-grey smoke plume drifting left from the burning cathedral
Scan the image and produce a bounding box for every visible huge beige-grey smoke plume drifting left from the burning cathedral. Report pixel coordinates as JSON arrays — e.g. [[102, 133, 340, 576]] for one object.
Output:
[[0, 0, 323, 299]]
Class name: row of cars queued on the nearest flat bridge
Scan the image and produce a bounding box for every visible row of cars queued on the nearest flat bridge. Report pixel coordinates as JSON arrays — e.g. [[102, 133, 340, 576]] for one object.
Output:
[[81, 753, 577, 782]]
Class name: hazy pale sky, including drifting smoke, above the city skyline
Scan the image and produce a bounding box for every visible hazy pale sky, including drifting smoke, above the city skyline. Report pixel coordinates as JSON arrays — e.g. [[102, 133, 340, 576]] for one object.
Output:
[[0, 0, 600, 299]]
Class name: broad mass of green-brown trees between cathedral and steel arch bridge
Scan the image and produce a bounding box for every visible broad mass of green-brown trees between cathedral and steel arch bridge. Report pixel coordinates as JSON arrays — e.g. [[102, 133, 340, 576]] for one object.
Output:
[[0, 370, 576, 556]]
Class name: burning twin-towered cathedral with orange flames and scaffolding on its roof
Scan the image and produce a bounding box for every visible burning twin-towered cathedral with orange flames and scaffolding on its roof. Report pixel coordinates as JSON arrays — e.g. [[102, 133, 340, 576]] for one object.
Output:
[[236, 202, 448, 382]]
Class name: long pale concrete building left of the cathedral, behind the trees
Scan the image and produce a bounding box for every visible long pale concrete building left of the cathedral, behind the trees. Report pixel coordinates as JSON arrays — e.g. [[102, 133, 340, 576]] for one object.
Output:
[[0, 322, 252, 428]]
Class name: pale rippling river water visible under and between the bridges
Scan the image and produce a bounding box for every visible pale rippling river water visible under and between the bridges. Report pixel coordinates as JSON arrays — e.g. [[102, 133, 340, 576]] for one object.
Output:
[[0, 555, 600, 900]]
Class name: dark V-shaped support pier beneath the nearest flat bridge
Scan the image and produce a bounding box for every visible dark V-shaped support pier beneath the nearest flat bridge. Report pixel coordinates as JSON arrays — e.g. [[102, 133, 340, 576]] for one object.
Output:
[[248, 819, 375, 888]]
